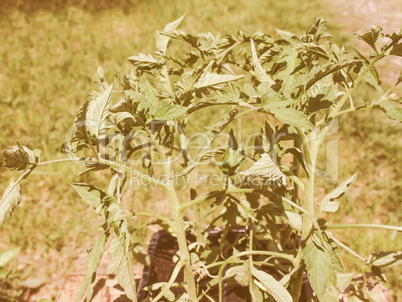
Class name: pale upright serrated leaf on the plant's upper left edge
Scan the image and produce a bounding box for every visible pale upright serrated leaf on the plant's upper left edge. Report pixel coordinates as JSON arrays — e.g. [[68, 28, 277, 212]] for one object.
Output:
[[85, 85, 113, 138]]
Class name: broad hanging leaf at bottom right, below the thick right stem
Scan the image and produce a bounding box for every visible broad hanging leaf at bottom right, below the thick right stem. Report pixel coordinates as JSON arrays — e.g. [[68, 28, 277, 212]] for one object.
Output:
[[303, 241, 339, 302]]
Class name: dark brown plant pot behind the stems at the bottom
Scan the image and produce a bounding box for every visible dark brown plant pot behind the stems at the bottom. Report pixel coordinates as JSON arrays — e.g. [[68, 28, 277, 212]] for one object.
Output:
[[138, 228, 313, 302]]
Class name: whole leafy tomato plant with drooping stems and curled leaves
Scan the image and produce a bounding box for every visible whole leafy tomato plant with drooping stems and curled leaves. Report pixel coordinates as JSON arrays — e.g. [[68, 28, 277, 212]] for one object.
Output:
[[0, 18, 402, 302]]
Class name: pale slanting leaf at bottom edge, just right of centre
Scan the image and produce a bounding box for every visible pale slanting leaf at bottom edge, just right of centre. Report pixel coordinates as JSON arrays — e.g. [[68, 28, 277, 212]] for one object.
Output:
[[250, 266, 293, 302]]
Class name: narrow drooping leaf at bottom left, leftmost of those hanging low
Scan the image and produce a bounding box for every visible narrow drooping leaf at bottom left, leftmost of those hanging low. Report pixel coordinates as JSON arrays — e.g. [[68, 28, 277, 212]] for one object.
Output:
[[75, 233, 108, 302]]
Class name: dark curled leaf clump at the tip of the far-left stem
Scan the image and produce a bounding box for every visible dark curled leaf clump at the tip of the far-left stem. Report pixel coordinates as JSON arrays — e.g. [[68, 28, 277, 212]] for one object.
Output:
[[3, 144, 37, 171]]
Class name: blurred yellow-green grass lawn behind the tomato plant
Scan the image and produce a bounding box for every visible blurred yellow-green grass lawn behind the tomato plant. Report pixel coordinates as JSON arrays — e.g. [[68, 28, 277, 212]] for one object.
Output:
[[0, 0, 402, 298]]
